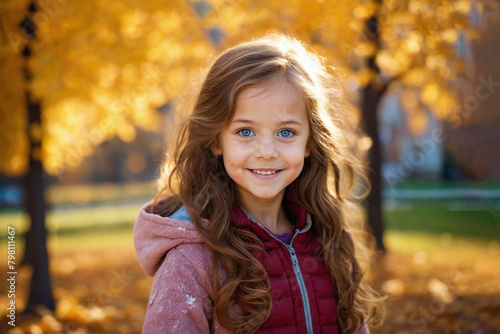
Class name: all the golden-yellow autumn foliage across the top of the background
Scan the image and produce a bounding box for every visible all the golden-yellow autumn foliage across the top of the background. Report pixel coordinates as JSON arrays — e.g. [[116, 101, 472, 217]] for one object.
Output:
[[0, 0, 485, 174]]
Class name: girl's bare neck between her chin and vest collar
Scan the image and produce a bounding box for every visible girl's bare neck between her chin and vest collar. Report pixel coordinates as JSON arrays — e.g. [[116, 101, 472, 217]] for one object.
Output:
[[241, 195, 292, 234]]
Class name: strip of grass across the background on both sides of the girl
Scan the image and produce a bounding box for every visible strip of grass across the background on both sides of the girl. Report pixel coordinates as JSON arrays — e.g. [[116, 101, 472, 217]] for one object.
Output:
[[0, 201, 500, 252]]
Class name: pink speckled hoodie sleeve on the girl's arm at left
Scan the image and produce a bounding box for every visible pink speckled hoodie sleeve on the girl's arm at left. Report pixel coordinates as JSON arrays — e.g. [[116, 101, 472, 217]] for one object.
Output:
[[142, 246, 212, 334]]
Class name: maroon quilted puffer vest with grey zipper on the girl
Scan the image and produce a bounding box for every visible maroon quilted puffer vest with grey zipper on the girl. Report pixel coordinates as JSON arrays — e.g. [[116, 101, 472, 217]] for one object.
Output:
[[231, 202, 339, 334]]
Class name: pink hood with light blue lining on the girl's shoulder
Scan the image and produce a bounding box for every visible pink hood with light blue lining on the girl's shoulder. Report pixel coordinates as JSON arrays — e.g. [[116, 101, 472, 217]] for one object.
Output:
[[134, 203, 202, 276]]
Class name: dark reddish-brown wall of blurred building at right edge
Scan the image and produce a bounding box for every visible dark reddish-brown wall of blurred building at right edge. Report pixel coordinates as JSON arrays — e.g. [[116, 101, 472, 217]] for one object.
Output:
[[443, 7, 500, 180]]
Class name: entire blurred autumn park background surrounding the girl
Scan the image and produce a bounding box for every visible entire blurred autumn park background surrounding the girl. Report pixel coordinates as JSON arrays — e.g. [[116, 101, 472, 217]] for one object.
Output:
[[0, 0, 500, 334]]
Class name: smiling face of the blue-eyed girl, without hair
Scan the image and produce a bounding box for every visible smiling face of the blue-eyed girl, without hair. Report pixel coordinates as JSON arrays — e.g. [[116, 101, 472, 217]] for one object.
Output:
[[215, 79, 309, 204]]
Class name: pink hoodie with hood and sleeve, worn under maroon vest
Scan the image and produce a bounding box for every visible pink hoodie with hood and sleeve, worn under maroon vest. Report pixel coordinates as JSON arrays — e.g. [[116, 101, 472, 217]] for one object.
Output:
[[134, 203, 369, 334]]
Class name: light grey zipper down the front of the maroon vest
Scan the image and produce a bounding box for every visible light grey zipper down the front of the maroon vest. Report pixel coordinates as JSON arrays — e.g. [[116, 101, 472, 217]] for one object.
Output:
[[241, 208, 314, 334]]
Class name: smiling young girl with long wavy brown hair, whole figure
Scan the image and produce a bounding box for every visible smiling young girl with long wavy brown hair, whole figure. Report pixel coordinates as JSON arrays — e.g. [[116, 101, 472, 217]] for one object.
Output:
[[134, 35, 380, 334]]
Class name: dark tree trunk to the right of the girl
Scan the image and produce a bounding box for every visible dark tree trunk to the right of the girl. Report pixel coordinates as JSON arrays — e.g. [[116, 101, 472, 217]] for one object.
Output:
[[361, 8, 387, 252]]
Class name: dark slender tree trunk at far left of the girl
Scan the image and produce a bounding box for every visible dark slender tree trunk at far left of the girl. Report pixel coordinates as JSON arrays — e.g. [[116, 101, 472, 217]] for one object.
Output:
[[21, 2, 55, 313]]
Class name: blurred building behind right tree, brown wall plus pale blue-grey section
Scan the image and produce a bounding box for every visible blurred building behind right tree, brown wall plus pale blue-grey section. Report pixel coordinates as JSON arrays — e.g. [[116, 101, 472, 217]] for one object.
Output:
[[379, 3, 500, 185]]
